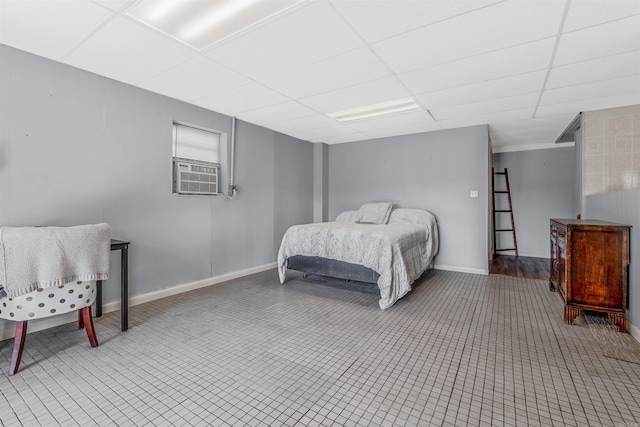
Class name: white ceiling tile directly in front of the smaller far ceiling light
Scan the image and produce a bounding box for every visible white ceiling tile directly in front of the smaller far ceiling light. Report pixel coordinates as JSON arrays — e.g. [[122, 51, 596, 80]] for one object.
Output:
[[300, 77, 411, 113]]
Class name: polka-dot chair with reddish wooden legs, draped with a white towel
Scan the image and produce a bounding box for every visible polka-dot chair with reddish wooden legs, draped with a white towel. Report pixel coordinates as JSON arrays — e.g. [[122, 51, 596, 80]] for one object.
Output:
[[0, 223, 111, 375]]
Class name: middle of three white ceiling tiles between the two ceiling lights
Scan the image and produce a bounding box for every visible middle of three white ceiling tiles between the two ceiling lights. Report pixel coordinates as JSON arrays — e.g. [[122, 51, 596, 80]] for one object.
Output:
[[262, 48, 391, 99]]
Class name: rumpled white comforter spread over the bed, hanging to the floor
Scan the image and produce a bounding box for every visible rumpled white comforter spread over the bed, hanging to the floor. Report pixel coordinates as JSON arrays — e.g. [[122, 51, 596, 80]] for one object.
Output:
[[278, 211, 438, 309]]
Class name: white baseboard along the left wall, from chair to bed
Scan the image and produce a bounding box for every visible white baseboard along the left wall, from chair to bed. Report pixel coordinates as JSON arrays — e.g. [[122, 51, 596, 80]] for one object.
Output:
[[0, 262, 277, 340]]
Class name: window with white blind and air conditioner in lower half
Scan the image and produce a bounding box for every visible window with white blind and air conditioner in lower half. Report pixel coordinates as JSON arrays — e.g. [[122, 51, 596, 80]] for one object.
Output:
[[172, 122, 226, 195]]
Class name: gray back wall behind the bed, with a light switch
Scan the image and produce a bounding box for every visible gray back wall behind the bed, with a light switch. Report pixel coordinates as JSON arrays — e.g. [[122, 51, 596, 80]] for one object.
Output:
[[329, 125, 489, 273]]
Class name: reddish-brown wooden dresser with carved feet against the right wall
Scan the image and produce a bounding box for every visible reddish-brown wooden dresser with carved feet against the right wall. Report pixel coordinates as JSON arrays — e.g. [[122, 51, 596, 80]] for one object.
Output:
[[549, 219, 630, 332]]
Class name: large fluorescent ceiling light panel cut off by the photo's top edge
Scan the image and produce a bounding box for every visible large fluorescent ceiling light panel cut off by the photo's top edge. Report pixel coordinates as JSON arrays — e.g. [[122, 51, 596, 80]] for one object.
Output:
[[127, 0, 300, 50]]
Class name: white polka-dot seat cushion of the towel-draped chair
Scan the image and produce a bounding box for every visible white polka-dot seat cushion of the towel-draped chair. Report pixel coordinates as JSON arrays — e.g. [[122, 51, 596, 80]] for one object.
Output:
[[0, 281, 96, 322]]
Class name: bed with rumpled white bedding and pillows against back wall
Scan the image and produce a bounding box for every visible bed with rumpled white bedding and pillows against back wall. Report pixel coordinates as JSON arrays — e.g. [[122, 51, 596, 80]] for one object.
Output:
[[278, 203, 438, 309]]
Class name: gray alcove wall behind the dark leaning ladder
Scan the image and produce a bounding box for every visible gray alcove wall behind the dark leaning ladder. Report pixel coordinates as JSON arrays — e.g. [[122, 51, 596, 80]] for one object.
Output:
[[493, 147, 576, 258]]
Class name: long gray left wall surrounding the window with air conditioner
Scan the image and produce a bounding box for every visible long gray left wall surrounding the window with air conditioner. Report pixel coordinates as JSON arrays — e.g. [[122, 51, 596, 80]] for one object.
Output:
[[0, 45, 313, 314]]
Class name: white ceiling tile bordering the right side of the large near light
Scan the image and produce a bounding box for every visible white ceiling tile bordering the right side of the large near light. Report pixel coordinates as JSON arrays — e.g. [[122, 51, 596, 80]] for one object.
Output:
[[207, 2, 364, 79]]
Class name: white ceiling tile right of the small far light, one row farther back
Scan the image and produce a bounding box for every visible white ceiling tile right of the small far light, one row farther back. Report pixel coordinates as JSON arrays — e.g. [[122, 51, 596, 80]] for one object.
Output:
[[429, 92, 539, 121]]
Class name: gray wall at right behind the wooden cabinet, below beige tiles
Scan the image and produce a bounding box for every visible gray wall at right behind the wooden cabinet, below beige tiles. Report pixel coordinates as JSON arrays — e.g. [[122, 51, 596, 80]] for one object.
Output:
[[582, 190, 640, 341]]
